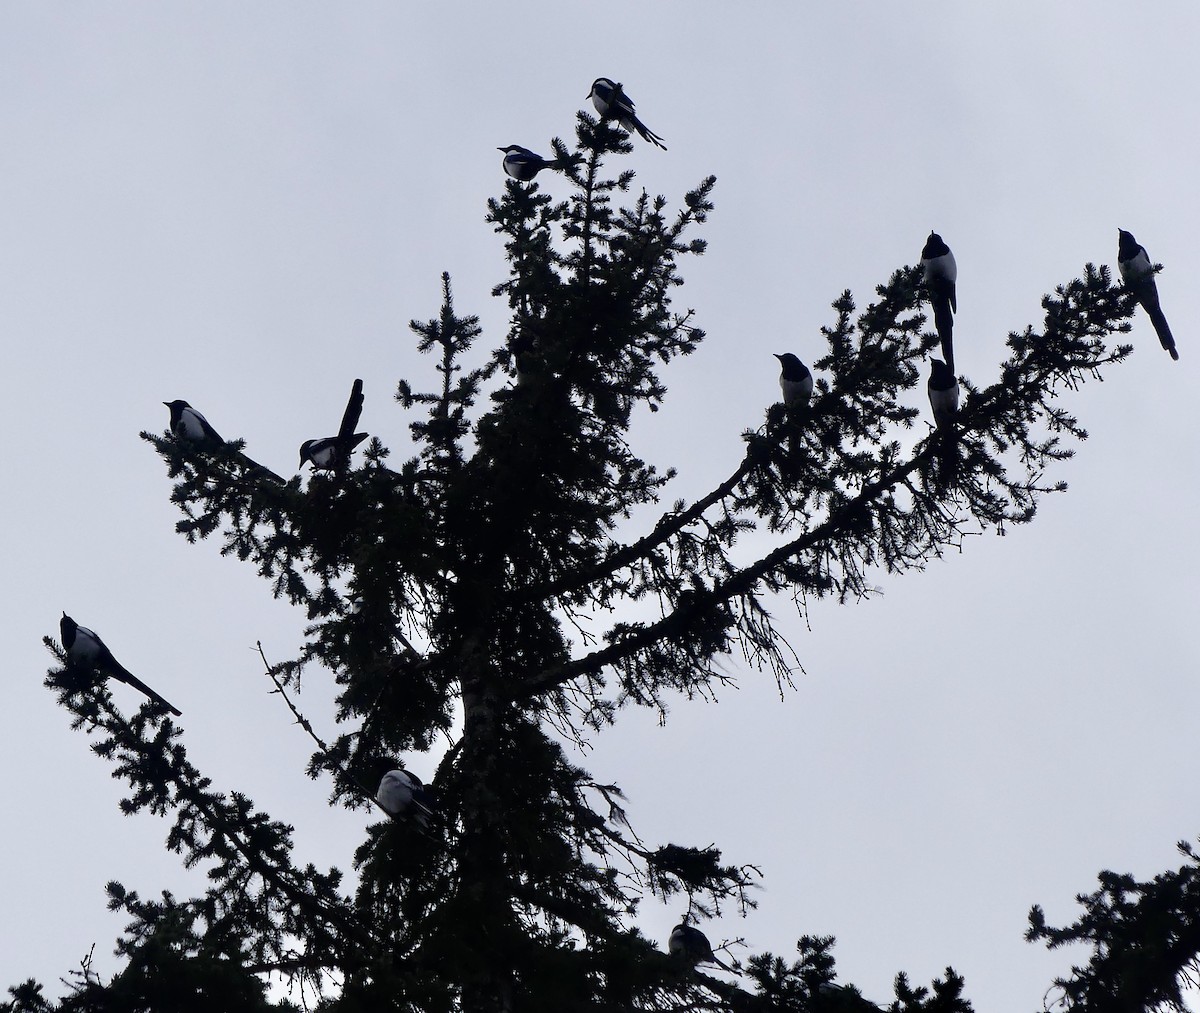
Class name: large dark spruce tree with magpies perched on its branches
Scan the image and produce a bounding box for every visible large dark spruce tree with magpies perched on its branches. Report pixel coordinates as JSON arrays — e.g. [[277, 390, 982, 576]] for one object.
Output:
[[16, 99, 1135, 1013]]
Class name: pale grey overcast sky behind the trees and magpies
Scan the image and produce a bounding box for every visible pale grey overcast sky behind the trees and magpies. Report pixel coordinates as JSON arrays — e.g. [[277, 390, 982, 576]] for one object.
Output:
[[0, 0, 1200, 1013]]
